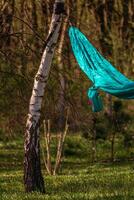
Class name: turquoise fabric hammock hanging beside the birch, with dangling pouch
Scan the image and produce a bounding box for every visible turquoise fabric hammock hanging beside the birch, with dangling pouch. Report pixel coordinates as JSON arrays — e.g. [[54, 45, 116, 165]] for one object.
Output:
[[69, 26, 134, 112]]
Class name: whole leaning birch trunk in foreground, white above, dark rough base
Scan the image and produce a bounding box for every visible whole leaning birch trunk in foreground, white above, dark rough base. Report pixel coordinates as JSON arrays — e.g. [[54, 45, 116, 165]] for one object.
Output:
[[24, 0, 64, 193]]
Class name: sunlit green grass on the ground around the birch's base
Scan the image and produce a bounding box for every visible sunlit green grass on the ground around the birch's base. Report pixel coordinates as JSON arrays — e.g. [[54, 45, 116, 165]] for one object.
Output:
[[0, 136, 134, 200]]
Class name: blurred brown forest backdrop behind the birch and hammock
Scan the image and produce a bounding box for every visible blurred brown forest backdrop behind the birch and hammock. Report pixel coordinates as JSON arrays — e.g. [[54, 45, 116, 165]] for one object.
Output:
[[0, 0, 134, 158]]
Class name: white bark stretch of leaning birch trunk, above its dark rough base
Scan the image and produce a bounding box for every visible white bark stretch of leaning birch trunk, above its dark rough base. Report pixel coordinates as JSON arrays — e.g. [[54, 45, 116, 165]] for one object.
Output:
[[28, 0, 64, 121]]
